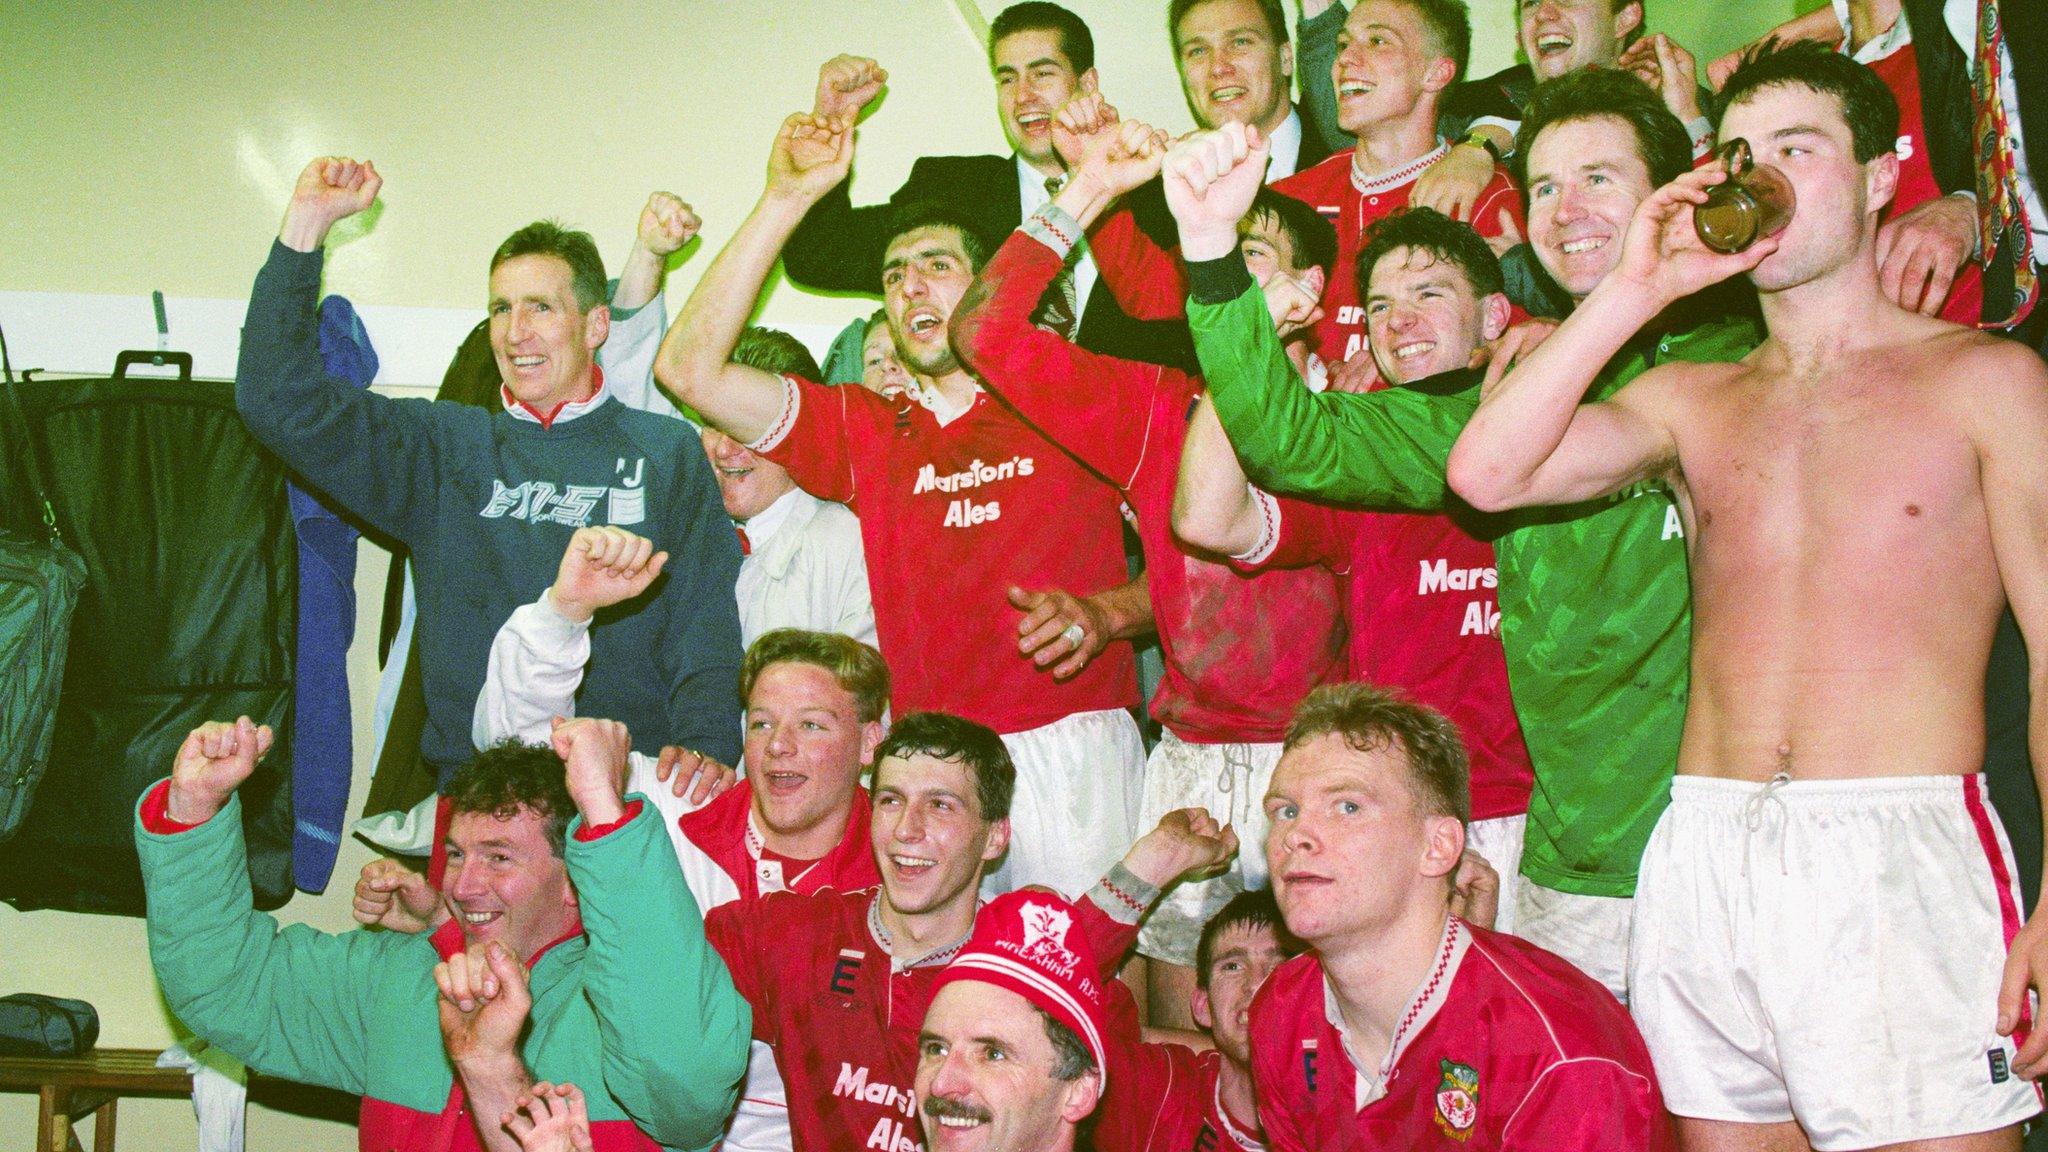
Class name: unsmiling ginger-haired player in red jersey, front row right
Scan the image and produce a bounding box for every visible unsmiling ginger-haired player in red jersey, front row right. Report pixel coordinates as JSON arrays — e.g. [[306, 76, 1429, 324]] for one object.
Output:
[[1251, 685, 1671, 1152]]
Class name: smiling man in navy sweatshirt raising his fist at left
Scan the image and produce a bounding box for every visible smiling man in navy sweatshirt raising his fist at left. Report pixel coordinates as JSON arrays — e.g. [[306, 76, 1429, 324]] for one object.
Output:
[[236, 156, 739, 779]]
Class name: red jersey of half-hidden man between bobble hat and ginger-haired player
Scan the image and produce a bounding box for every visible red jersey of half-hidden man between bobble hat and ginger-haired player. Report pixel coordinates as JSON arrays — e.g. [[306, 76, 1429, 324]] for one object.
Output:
[[1096, 1035, 1266, 1152]]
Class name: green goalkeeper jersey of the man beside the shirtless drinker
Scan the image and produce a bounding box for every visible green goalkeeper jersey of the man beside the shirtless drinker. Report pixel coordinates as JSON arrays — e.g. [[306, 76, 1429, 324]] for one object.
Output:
[[1188, 256, 1761, 896]]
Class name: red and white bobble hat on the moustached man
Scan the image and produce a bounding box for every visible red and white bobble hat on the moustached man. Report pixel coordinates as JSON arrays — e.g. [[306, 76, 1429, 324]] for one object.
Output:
[[932, 890, 1108, 1086]]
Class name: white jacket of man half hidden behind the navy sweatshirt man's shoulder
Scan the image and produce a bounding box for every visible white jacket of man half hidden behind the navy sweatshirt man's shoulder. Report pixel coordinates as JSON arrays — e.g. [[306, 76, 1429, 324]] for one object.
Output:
[[733, 481, 877, 648]]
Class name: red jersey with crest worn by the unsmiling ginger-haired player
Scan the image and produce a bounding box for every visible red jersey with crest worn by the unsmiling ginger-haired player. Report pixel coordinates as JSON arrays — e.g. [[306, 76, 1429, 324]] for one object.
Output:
[[1251, 918, 1671, 1152]]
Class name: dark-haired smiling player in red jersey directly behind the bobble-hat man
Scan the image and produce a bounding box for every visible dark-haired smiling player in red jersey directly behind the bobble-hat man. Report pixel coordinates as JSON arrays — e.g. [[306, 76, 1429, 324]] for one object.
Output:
[[707, 713, 1237, 1152]]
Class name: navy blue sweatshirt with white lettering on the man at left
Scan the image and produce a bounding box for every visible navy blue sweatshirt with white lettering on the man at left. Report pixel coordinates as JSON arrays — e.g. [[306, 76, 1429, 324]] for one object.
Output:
[[236, 244, 739, 781]]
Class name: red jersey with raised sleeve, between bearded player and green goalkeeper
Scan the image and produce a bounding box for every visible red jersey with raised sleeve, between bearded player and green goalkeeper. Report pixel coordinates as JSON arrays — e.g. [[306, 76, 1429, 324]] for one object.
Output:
[[954, 232, 1343, 744]]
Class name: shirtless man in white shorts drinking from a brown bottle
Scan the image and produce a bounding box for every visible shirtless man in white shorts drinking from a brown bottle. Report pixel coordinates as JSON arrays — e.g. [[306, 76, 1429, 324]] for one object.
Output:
[[1450, 45, 2048, 1150]]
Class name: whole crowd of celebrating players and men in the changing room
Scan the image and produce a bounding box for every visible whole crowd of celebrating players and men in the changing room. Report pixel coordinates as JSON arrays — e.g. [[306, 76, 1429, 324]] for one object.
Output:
[[137, 0, 2048, 1152]]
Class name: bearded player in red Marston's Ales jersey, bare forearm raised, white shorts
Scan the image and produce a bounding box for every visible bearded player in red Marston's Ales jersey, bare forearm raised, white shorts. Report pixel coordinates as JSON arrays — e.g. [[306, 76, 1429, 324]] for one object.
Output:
[[655, 113, 1151, 892]]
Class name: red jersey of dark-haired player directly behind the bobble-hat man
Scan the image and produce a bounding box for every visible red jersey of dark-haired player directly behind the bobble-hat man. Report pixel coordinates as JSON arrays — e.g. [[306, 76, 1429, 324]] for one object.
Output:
[[705, 890, 1137, 1152]]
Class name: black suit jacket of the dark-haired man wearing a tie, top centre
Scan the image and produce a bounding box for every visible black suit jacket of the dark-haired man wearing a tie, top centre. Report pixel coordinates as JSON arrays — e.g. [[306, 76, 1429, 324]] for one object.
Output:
[[782, 152, 1196, 371]]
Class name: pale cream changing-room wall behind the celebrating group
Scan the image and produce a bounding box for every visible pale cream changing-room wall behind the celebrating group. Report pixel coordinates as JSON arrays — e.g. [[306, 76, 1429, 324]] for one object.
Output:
[[0, 0, 1812, 1152]]
